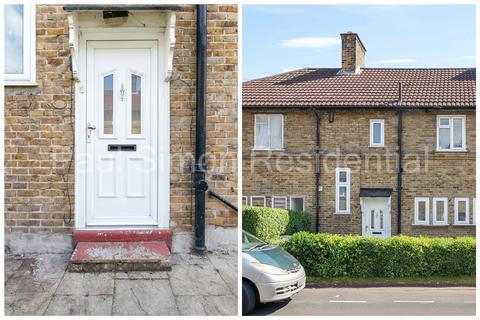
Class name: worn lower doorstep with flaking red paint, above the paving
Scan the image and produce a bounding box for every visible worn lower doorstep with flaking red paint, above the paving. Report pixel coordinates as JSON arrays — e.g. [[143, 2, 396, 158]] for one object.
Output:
[[68, 241, 172, 272]]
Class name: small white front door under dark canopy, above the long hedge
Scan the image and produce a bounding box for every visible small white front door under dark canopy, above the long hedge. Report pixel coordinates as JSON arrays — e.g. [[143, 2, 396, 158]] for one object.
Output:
[[362, 198, 391, 238]]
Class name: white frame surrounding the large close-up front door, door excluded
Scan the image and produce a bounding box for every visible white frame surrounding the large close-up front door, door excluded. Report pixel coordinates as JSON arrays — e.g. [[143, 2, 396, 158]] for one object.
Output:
[[75, 28, 174, 229]]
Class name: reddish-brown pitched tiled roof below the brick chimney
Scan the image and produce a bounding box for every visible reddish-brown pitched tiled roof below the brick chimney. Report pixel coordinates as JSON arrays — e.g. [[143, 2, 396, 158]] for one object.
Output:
[[242, 68, 475, 108]]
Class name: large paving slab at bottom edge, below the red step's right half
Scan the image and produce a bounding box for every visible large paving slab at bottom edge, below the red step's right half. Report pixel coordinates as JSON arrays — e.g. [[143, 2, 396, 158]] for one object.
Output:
[[112, 280, 179, 316]]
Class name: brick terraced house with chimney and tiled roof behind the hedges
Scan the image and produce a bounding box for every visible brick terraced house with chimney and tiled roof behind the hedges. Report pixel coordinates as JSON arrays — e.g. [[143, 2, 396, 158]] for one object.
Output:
[[242, 32, 476, 237]]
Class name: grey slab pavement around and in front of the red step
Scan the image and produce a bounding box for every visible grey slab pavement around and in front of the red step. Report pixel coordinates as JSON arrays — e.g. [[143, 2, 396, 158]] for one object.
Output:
[[5, 252, 238, 316]]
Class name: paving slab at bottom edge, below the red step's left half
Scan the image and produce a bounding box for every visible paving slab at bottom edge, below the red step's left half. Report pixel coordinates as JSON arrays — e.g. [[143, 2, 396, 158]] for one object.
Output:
[[45, 295, 113, 316]]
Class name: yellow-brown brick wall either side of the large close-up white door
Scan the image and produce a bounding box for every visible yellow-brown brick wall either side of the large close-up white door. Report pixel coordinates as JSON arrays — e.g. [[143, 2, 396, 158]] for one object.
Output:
[[5, 5, 237, 233]]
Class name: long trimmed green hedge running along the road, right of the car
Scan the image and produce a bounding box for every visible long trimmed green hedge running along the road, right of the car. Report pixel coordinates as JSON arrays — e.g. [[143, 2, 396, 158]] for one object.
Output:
[[281, 232, 475, 278]]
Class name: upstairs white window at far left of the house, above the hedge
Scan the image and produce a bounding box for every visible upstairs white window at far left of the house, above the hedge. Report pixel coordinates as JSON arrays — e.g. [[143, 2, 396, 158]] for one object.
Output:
[[254, 114, 283, 150]]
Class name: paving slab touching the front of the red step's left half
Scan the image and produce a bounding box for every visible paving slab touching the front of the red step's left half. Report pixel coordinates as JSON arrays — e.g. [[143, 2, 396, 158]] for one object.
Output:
[[56, 272, 114, 296]]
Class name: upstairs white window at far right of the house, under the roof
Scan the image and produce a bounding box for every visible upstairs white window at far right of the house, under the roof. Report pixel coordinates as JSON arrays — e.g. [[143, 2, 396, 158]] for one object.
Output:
[[437, 116, 467, 151]]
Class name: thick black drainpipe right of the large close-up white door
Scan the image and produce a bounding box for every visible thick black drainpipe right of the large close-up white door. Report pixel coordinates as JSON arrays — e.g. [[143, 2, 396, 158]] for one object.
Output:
[[194, 4, 208, 253]]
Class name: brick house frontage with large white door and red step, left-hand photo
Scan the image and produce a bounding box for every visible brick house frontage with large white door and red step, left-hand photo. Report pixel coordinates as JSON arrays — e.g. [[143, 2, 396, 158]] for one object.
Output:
[[4, 2, 238, 269]]
